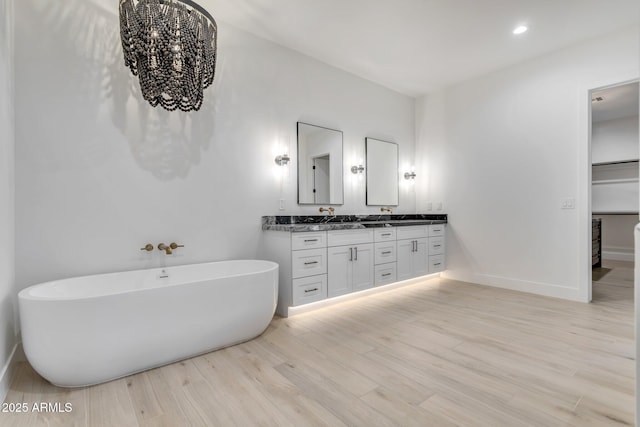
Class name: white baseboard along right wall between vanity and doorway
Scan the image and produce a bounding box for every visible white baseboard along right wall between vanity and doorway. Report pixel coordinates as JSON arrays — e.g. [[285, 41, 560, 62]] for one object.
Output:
[[441, 270, 588, 302]]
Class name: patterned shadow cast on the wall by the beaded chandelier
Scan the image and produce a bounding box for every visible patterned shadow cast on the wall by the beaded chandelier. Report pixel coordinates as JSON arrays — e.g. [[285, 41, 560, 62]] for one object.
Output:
[[29, 0, 217, 180]]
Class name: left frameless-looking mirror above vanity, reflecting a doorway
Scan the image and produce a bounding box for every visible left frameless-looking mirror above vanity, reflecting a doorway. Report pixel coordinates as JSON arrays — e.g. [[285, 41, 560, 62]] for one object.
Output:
[[298, 122, 344, 205]]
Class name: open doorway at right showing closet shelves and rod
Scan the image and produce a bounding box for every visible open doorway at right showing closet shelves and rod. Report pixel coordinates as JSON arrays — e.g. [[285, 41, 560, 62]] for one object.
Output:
[[590, 81, 640, 301]]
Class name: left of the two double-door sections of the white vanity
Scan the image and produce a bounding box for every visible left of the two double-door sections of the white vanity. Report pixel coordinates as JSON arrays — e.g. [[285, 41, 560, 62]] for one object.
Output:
[[327, 230, 374, 297]]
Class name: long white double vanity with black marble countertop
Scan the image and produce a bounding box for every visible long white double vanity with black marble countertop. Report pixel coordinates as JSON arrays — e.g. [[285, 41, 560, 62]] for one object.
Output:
[[262, 214, 447, 317]]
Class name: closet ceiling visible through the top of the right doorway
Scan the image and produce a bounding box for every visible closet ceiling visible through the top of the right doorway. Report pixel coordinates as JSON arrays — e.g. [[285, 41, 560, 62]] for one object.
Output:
[[591, 82, 640, 122]]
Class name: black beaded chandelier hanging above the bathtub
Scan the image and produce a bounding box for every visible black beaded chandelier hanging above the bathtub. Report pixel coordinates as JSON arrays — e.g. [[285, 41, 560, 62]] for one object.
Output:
[[120, 0, 218, 111]]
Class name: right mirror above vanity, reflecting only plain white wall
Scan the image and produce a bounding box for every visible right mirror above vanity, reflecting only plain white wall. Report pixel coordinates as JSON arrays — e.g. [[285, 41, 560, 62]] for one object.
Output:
[[365, 138, 398, 206]]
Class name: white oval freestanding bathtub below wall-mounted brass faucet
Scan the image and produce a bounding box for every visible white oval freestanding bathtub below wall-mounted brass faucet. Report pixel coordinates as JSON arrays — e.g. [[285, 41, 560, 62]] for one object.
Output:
[[18, 260, 278, 387]]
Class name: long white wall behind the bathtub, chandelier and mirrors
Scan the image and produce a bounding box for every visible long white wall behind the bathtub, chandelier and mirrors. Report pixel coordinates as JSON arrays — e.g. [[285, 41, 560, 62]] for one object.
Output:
[[16, 0, 415, 287]]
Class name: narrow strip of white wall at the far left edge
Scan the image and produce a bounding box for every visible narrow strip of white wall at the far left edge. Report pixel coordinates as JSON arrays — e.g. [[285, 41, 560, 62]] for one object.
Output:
[[0, 0, 18, 402]]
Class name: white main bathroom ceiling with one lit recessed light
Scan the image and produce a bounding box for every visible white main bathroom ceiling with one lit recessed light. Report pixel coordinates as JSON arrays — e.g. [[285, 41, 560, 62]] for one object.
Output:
[[202, 0, 640, 96]]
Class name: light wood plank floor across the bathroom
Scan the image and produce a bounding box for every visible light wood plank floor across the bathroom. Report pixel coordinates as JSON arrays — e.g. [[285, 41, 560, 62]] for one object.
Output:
[[0, 263, 635, 427]]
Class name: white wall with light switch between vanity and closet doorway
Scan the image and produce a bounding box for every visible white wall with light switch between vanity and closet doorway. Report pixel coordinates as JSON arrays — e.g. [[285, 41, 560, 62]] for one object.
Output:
[[416, 28, 639, 300]]
